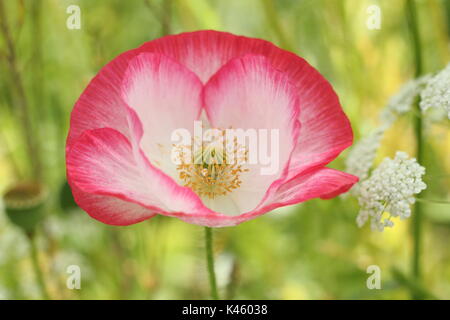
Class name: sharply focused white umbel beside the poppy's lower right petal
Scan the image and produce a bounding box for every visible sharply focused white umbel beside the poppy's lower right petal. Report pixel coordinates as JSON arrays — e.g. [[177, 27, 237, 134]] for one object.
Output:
[[356, 151, 427, 231]]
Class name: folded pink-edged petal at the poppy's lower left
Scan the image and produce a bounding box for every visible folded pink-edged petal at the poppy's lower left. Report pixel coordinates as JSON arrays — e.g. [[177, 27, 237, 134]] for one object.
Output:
[[67, 128, 215, 222]]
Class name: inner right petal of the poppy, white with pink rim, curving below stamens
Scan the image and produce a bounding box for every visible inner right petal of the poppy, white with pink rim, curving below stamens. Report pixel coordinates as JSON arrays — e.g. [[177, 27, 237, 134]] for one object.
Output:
[[203, 55, 299, 215]]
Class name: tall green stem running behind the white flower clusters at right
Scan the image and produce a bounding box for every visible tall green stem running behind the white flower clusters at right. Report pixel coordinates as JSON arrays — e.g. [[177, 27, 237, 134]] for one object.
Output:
[[406, 0, 424, 290]]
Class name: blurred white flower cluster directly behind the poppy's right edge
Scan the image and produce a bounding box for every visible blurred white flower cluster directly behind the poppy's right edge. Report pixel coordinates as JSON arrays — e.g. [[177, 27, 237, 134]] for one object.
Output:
[[345, 129, 384, 194]]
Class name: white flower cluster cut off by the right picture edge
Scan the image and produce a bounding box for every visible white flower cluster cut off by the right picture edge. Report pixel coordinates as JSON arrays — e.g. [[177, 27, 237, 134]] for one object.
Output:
[[420, 64, 450, 119]]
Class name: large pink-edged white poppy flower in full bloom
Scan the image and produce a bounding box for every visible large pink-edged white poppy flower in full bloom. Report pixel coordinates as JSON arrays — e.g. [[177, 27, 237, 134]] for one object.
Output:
[[66, 31, 357, 227]]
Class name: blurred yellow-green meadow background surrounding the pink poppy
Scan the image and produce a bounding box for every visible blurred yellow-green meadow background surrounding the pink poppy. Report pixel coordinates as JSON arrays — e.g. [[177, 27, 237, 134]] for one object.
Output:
[[0, 0, 450, 299]]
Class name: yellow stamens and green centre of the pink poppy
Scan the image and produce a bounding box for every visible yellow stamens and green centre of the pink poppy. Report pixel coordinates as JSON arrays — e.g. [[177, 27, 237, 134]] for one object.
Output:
[[177, 130, 248, 199]]
